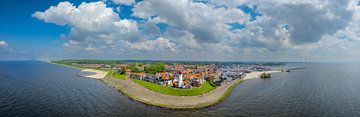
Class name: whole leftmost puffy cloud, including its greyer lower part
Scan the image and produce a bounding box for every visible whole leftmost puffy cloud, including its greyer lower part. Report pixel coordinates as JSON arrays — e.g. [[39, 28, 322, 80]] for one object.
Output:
[[33, 1, 138, 53]]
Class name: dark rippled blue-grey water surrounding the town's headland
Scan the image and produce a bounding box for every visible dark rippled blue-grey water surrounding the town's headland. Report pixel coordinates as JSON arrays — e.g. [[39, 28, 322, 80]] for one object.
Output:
[[0, 61, 360, 117]]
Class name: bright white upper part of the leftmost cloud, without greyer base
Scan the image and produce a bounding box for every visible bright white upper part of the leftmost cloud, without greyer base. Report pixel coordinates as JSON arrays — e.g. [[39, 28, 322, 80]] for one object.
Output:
[[32, 1, 137, 32]]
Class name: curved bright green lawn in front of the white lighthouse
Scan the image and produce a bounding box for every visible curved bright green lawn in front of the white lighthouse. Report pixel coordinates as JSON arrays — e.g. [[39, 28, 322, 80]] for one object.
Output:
[[131, 79, 216, 96]]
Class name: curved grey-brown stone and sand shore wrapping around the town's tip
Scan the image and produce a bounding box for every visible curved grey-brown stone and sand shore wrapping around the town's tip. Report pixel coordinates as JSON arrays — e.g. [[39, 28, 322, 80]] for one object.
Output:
[[101, 71, 281, 109]]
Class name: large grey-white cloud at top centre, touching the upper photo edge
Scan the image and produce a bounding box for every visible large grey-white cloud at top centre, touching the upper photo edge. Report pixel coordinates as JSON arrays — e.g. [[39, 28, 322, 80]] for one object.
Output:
[[133, 0, 249, 43]]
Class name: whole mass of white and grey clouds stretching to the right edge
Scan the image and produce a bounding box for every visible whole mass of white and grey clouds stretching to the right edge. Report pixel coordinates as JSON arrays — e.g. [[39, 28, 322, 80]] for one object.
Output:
[[33, 0, 360, 59]]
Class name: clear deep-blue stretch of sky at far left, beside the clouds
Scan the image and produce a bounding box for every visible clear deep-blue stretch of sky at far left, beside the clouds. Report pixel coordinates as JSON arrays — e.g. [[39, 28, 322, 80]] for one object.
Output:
[[0, 0, 94, 60]]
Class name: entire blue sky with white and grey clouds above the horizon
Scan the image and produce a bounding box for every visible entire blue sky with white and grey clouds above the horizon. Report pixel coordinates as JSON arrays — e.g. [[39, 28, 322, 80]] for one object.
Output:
[[0, 0, 360, 61]]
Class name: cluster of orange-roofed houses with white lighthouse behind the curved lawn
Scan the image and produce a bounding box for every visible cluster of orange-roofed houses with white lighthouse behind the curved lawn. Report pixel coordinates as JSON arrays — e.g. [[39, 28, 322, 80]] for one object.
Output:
[[129, 64, 221, 88]]
